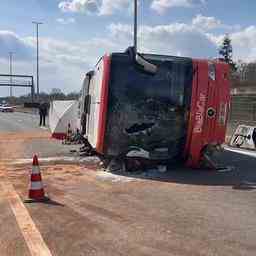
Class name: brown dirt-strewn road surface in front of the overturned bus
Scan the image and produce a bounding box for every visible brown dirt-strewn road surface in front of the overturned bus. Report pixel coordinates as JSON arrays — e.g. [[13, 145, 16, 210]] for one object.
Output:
[[0, 131, 256, 256]]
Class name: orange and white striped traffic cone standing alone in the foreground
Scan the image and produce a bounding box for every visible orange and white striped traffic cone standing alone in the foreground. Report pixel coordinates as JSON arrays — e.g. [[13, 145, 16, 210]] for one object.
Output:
[[25, 155, 49, 203]]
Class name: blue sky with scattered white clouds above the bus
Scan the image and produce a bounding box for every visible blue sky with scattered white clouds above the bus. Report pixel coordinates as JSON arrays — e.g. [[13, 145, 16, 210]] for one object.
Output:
[[0, 0, 256, 97]]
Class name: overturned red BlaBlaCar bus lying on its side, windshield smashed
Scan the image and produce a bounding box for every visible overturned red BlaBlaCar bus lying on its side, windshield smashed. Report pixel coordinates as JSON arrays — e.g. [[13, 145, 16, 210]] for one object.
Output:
[[81, 48, 230, 168]]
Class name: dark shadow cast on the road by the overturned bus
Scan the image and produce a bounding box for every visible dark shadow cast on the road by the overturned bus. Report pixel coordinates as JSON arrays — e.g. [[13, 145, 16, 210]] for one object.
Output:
[[111, 151, 256, 190]]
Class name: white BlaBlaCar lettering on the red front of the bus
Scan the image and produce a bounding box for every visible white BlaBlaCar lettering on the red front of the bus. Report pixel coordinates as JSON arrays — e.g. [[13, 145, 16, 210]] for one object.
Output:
[[193, 93, 206, 133]]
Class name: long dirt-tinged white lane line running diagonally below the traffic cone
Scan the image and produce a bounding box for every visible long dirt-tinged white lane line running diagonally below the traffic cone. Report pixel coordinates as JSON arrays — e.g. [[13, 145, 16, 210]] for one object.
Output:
[[0, 180, 52, 256]]
